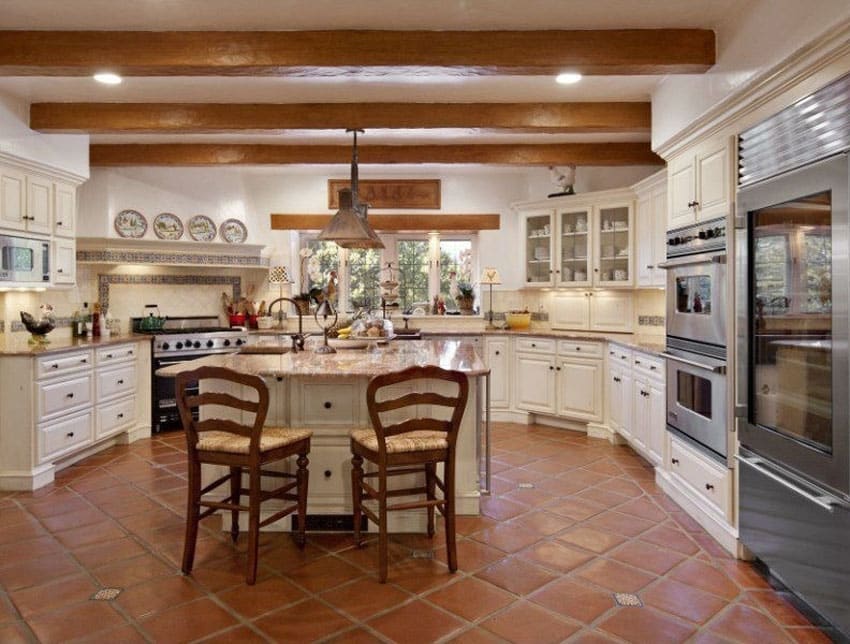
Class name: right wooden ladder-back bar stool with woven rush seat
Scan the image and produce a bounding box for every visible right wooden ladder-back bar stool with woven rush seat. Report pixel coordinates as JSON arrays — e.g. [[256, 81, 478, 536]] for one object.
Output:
[[351, 366, 469, 583]]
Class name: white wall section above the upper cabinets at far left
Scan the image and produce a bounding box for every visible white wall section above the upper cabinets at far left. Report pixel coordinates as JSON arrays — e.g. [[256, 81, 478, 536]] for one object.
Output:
[[0, 94, 89, 177]]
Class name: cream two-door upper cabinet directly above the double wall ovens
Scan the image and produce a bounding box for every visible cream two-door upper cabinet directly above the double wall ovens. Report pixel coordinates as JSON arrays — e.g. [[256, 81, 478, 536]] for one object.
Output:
[[667, 138, 734, 230]]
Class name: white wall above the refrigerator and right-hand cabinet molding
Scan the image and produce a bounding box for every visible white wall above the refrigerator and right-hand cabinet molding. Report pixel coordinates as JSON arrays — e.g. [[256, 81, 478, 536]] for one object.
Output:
[[652, 0, 850, 149]]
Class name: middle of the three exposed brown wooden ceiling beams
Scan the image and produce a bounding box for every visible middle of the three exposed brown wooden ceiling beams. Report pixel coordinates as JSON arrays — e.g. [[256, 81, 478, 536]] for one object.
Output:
[[30, 103, 651, 134]]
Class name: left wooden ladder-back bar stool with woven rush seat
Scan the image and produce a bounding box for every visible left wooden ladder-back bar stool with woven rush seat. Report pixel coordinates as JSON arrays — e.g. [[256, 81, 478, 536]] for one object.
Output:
[[176, 367, 313, 584]]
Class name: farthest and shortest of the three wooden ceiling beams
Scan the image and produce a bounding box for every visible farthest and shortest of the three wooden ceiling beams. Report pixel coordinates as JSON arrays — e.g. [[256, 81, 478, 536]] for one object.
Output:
[[89, 143, 664, 166]]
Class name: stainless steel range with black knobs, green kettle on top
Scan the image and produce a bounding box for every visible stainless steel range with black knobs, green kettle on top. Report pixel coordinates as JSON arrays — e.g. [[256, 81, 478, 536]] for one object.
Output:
[[132, 316, 248, 433]]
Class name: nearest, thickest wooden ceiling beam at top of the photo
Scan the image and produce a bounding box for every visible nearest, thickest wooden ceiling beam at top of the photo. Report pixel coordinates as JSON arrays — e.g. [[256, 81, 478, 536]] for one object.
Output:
[[0, 29, 715, 76]]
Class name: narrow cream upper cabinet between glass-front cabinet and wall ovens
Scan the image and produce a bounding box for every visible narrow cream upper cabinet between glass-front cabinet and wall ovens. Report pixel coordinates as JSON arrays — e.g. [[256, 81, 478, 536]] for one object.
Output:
[[634, 170, 667, 288]]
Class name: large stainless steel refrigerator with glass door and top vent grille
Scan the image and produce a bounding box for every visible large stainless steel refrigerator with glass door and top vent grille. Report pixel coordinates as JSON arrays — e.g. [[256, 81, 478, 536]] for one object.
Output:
[[735, 69, 850, 634]]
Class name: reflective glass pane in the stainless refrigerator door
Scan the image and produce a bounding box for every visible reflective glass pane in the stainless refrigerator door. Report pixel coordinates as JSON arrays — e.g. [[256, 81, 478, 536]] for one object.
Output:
[[749, 192, 833, 454]]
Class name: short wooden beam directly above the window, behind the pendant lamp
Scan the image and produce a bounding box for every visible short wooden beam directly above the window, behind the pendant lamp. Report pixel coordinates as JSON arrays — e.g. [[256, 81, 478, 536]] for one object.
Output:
[[271, 213, 500, 232]]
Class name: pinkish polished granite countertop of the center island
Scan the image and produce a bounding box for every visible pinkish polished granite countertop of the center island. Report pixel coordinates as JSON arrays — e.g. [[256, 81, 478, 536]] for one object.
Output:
[[156, 340, 489, 377]]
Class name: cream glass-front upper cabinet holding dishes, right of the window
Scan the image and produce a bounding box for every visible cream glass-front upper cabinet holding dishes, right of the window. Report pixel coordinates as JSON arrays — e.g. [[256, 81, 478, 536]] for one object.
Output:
[[519, 193, 634, 288]]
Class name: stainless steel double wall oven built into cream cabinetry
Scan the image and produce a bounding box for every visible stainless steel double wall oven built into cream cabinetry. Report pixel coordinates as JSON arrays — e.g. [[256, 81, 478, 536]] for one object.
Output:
[[661, 219, 729, 461]]
